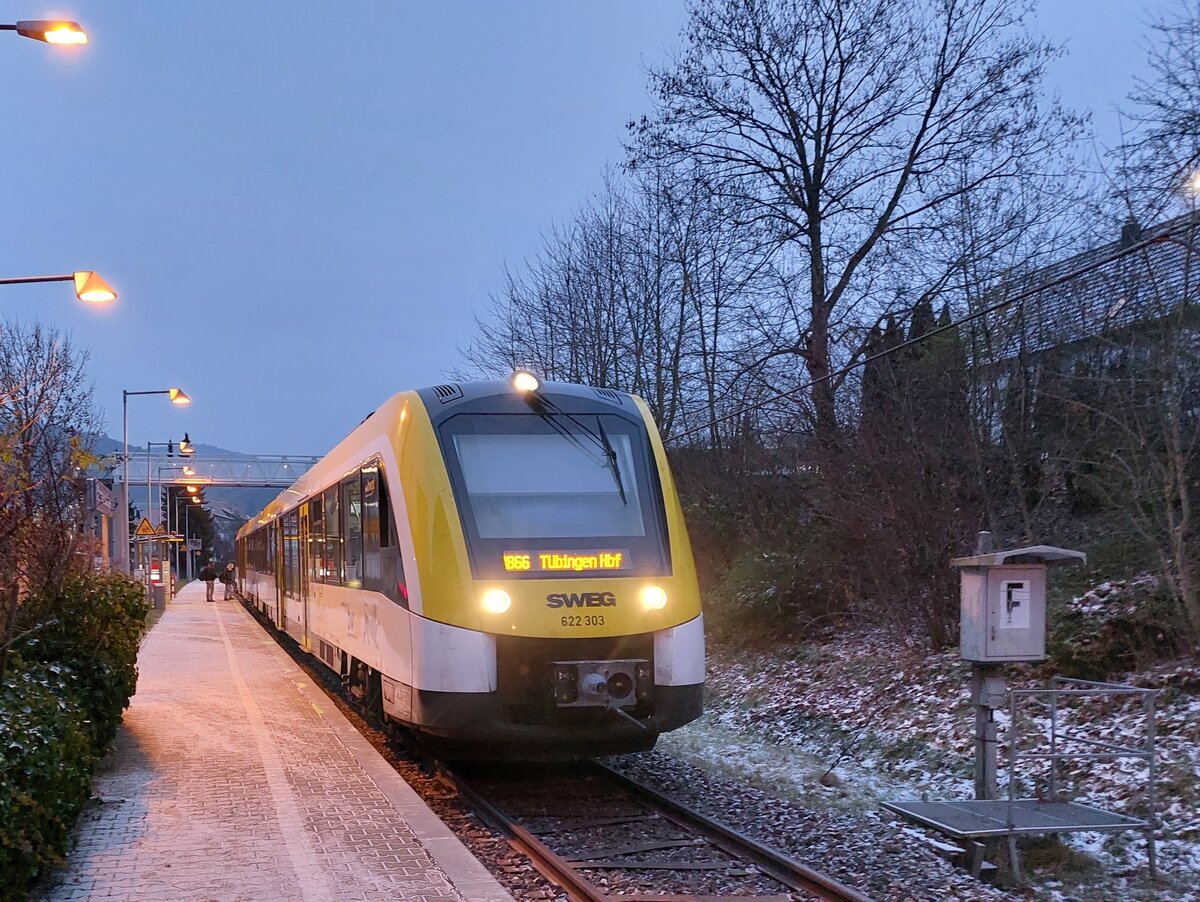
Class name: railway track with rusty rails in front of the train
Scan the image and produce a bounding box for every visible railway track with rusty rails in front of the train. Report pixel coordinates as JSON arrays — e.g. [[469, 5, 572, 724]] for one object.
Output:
[[440, 762, 869, 902]]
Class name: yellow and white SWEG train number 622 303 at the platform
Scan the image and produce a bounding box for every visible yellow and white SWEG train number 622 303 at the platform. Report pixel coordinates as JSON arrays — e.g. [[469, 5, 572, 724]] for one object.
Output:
[[238, 372, 704, 758]]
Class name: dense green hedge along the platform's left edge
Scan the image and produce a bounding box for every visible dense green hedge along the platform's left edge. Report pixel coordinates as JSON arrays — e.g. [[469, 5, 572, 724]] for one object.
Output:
[[0, 573, 149, 902]]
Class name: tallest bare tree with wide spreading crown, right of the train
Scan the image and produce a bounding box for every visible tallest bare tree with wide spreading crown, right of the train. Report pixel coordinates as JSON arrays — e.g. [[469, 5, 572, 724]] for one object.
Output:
[[635, 0, 1078, 448]]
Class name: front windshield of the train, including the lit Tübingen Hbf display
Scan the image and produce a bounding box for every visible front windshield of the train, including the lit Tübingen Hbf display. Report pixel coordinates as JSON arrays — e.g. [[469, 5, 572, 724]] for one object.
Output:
[[443, 413, 668, 577]]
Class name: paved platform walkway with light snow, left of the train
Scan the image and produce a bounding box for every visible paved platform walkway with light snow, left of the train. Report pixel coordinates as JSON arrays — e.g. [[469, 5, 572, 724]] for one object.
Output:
[[46, 582, 511, 902]]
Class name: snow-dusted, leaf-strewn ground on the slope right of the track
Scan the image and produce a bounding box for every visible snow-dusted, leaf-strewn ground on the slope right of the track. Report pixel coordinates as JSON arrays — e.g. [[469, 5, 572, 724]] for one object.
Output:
[[676, 628, 1200, 902]]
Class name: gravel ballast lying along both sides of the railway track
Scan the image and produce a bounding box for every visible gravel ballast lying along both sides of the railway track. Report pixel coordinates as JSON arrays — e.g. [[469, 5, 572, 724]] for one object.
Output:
[[250, 594, 1190, 902]]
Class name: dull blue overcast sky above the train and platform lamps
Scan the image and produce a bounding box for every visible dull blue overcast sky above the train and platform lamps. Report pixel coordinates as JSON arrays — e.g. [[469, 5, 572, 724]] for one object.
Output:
[[0, 0, 1169, 453]]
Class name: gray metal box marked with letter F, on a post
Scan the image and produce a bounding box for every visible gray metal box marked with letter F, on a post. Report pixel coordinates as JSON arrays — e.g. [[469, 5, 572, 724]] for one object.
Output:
[[950, 545, 1086, 663]]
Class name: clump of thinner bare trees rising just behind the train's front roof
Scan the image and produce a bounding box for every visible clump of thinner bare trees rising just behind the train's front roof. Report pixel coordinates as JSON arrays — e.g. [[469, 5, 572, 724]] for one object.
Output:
[[458, 166, 763, 446]]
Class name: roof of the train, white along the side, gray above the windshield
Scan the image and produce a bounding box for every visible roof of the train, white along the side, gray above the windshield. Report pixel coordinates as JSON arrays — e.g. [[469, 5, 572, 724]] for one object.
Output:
[[238, 379, 637, 539]]
